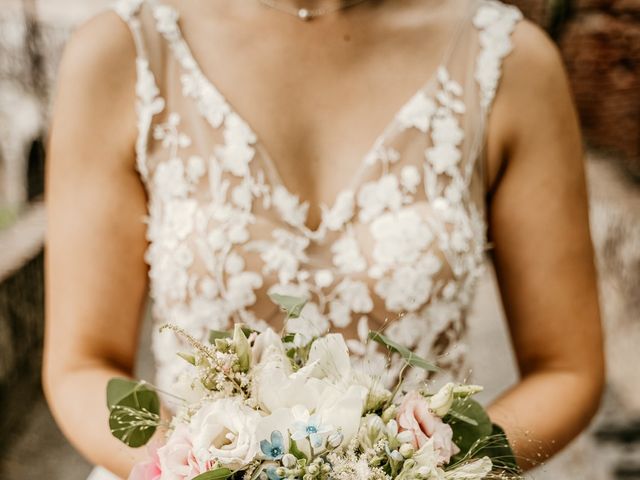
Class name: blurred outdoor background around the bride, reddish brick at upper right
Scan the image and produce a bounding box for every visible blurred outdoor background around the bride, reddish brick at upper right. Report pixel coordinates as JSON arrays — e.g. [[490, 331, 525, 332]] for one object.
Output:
[[0, 0, 640, 480]]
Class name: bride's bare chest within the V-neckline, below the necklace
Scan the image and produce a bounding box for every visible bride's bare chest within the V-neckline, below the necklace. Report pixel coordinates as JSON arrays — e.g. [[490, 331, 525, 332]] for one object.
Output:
[[168, 2, 463, 227]]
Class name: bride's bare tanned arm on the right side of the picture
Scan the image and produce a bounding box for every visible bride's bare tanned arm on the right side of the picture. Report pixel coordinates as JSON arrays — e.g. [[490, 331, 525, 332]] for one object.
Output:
[[487, 21, 604, 468]]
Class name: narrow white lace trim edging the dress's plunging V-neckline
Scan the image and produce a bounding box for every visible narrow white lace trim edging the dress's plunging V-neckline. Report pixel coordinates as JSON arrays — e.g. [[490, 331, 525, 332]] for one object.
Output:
[[150, 0, 469, 236]]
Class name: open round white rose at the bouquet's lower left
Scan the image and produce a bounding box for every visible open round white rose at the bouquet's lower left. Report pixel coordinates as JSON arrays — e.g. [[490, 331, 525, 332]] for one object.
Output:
[[189, 398, 260, 469]]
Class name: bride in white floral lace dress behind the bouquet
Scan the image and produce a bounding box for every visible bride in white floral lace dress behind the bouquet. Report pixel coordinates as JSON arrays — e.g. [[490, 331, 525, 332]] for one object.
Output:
[[44, 0, 603, 477]]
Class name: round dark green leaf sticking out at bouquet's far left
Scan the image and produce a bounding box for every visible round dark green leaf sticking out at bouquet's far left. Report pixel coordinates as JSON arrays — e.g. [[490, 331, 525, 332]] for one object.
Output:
[[107, 378, 160, 448]]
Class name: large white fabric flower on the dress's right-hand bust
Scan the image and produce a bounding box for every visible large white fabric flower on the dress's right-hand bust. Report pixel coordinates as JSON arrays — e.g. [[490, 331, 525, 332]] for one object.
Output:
[[370, 208, 433, 269]]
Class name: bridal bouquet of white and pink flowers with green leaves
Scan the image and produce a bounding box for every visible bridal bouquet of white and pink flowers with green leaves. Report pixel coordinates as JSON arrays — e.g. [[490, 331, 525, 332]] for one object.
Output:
[[107, 295, 519, 480]]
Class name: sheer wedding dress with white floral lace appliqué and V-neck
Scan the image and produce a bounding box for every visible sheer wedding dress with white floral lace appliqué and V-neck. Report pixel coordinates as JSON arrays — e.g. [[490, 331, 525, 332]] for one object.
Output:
[[87, 0, 522, 478]]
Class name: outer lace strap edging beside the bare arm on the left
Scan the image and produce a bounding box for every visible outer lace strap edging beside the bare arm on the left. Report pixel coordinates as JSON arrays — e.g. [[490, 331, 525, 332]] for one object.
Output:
[[112, 0, 165, 182]]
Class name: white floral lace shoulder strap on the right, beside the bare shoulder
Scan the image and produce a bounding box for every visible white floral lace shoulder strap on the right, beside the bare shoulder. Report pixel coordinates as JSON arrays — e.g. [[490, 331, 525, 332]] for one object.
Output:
[[473, 0, 523, 112]]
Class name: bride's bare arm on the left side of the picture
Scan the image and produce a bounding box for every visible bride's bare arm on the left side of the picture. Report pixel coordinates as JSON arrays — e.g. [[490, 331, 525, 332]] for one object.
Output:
[[43, 12, 147, 477]]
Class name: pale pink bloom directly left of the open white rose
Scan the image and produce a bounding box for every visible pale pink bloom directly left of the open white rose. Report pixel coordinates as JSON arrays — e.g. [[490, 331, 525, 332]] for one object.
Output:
[[156, 424, 207, 480]]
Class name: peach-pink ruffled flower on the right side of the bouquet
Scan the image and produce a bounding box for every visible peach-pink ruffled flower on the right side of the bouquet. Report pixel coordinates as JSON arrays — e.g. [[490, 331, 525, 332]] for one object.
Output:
[[397, 392, 460, 465]]
